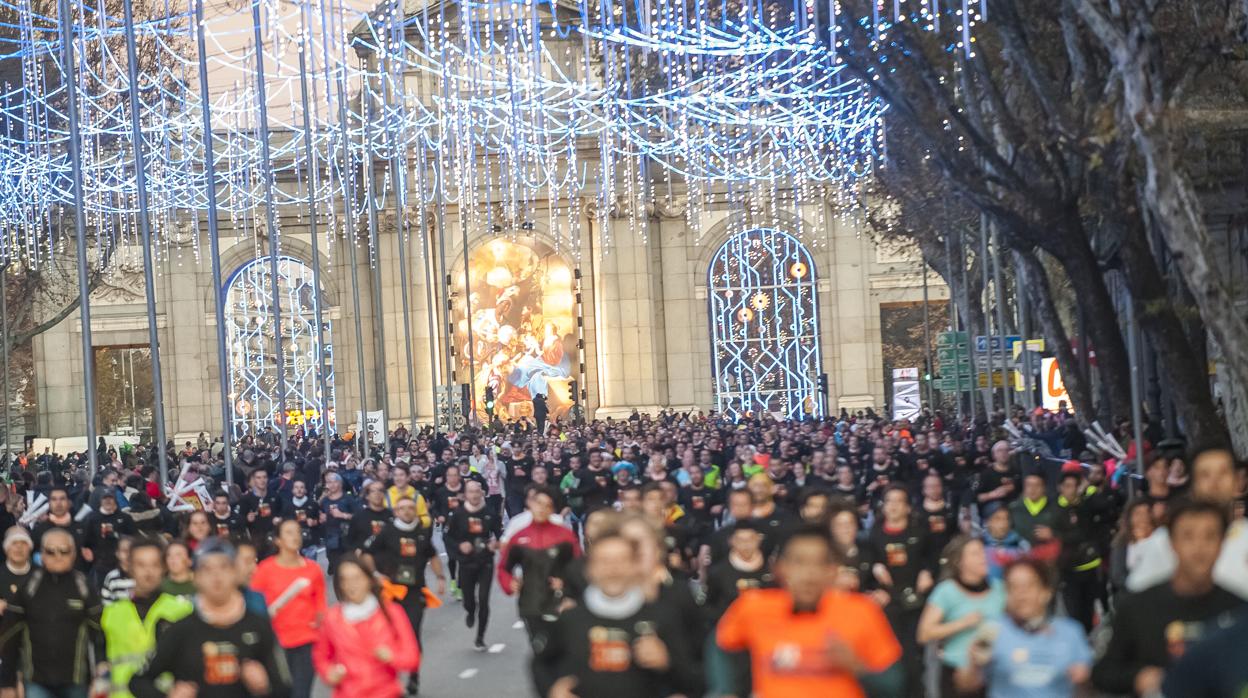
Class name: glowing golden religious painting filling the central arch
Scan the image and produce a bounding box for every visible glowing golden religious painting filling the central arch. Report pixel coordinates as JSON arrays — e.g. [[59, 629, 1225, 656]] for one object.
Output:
[[456, 238, 578, 421]]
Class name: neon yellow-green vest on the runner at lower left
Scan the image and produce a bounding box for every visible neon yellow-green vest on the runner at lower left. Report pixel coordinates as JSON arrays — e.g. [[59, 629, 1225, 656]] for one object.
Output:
[[100, 593, 195, 698]]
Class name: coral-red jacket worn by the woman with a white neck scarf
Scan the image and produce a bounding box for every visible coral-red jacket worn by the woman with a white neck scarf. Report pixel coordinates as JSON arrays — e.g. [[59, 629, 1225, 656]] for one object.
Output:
[[312, 602, 421, 698]]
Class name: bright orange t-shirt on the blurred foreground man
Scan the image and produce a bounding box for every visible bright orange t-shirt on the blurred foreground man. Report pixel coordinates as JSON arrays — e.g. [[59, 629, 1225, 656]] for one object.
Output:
[[716, 589, 901, 698]]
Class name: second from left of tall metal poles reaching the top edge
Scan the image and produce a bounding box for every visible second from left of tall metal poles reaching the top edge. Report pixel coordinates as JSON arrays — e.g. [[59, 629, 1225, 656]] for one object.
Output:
[[121, 2, 168, 491]]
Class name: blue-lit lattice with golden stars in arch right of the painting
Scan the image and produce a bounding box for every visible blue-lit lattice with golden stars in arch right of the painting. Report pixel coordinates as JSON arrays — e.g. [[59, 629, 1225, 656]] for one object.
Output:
[[706, 229, 822, 420]]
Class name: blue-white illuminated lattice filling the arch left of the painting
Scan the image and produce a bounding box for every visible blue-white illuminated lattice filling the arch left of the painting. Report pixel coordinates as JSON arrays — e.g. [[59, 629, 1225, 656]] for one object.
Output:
[[225, 257, 334, 437]]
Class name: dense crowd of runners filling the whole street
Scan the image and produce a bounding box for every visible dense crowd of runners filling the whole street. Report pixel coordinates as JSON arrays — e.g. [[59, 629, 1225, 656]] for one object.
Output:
[[0, 411, 1248, 698]]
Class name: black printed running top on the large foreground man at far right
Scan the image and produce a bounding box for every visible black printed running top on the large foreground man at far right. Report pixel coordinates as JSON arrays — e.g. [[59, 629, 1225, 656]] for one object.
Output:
[[1092, 582, 1243, 693]]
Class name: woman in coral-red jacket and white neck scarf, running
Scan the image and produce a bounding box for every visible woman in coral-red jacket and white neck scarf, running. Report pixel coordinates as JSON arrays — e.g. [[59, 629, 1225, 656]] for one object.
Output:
[[312, 554, 421, 698]]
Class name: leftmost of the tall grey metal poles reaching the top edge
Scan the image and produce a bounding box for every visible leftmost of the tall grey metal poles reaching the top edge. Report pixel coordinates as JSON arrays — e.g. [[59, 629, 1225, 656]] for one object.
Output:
[[58, 0, 99, 481]]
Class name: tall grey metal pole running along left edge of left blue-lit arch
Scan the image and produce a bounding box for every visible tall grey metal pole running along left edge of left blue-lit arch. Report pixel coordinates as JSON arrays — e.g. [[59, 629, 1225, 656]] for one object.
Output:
[[193, 0, 233, 487]]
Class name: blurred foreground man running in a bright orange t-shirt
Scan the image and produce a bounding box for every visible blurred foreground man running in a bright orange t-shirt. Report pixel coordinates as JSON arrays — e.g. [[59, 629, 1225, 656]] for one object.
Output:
[[716, 528, 905, 698]]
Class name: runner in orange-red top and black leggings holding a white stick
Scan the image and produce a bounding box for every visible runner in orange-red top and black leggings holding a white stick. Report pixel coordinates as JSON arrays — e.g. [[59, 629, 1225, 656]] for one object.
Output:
[[251, 518, 326, 698]]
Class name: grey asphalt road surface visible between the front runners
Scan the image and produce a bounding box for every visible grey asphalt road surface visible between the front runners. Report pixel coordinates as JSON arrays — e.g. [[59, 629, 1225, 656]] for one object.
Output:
[[313, 537, 534, 698]]
